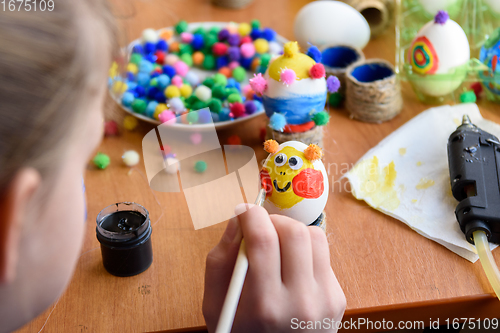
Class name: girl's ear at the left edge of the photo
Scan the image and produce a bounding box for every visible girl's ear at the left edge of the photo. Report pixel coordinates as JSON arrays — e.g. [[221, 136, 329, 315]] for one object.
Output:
[[0, 168, 41, 284]]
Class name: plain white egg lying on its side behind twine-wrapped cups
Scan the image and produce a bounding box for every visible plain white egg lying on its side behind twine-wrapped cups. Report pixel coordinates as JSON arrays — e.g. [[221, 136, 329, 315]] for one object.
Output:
[[294, 1, 370, 50]]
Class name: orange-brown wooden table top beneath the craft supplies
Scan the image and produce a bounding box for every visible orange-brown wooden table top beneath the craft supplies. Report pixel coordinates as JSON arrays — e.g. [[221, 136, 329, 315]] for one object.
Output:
[[15, 0, 500, 333]]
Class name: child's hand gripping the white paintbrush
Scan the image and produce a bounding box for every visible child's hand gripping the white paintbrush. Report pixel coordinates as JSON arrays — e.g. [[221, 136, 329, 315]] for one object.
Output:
[[203, 206, 346, 333]]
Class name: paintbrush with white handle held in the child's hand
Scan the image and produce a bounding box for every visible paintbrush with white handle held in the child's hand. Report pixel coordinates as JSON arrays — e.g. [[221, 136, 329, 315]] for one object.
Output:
[[215, 189, 266, 333]]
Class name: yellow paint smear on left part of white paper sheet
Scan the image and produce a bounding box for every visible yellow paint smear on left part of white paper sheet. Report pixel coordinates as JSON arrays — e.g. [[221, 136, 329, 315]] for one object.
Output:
[[353, 156, 400, 211]]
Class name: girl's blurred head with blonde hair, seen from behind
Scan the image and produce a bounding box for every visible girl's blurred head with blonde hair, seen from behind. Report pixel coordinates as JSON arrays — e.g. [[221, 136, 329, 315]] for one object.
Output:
[[0, 0, 116, 332]]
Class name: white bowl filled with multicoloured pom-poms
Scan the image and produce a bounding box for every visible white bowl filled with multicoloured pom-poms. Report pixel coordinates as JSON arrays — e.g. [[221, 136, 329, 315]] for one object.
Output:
[[108, 20, 287, 129]]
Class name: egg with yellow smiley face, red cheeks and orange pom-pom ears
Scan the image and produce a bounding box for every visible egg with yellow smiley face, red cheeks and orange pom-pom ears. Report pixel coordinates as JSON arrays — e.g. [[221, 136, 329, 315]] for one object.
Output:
[[260, 140, 329, 225]]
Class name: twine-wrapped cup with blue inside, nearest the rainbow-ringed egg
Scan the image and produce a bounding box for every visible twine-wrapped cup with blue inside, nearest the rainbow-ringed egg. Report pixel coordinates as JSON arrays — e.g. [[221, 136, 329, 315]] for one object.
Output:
[[346, 59, 403, 123]]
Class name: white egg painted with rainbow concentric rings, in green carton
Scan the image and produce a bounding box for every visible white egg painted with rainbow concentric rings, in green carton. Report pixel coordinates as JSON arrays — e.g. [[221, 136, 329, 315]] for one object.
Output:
[[408, 13, 470, 97]]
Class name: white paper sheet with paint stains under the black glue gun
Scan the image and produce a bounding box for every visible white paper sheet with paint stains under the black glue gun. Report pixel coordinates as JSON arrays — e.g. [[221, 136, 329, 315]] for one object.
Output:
[[346, 104, 500, 262]]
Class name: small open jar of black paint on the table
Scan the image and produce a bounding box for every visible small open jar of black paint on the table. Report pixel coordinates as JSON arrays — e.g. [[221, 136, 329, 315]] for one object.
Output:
[[96, 202, 153, 276]]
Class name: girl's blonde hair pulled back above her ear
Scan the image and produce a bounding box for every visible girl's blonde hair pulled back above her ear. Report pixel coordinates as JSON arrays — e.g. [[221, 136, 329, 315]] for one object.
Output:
[[0, 0, 117, 194]]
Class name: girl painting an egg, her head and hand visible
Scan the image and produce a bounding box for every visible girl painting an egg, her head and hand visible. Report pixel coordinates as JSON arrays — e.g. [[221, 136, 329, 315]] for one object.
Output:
[[0, 0, 345, 332]]
